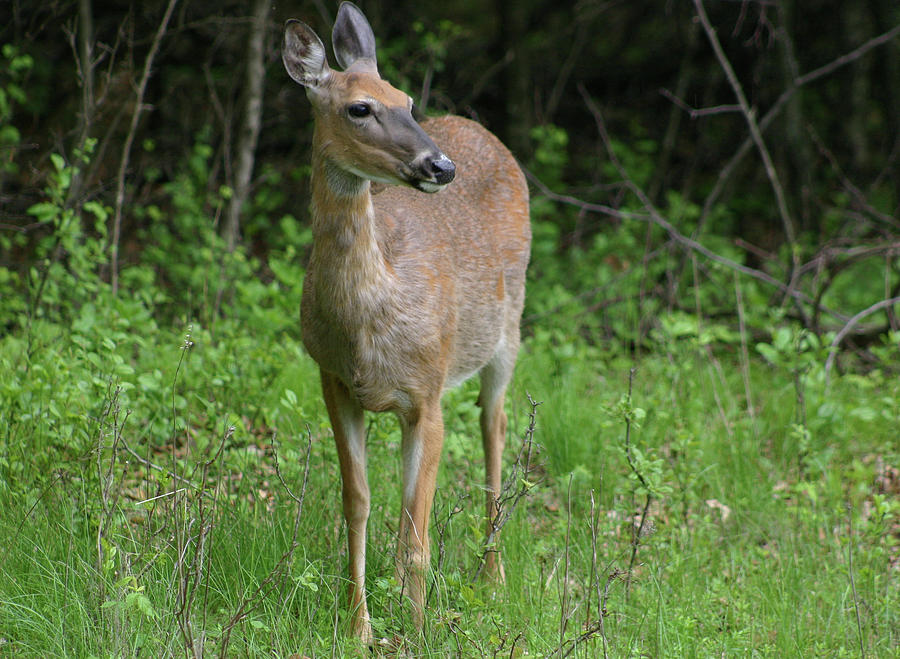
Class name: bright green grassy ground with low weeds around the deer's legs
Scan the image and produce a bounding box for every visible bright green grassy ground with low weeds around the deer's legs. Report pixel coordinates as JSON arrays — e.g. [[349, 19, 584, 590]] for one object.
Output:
[[0, 312, 900, 657]]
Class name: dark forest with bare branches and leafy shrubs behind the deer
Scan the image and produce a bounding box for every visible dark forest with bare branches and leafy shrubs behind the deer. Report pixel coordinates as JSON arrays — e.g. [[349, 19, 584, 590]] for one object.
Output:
[[0, 0, 900, 356]]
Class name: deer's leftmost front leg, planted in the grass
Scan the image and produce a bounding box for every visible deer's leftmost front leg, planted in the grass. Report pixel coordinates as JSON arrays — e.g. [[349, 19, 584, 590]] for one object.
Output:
[[322, 371, 374, 645]]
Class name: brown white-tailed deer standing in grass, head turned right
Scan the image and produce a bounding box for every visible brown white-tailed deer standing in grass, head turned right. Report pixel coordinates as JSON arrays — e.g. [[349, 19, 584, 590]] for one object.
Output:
[[282, 2, 531, 643]]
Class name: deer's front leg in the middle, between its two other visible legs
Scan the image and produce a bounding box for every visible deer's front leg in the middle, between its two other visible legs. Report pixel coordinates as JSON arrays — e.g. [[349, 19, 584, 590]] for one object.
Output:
[[397, 398, 444, 628]]
